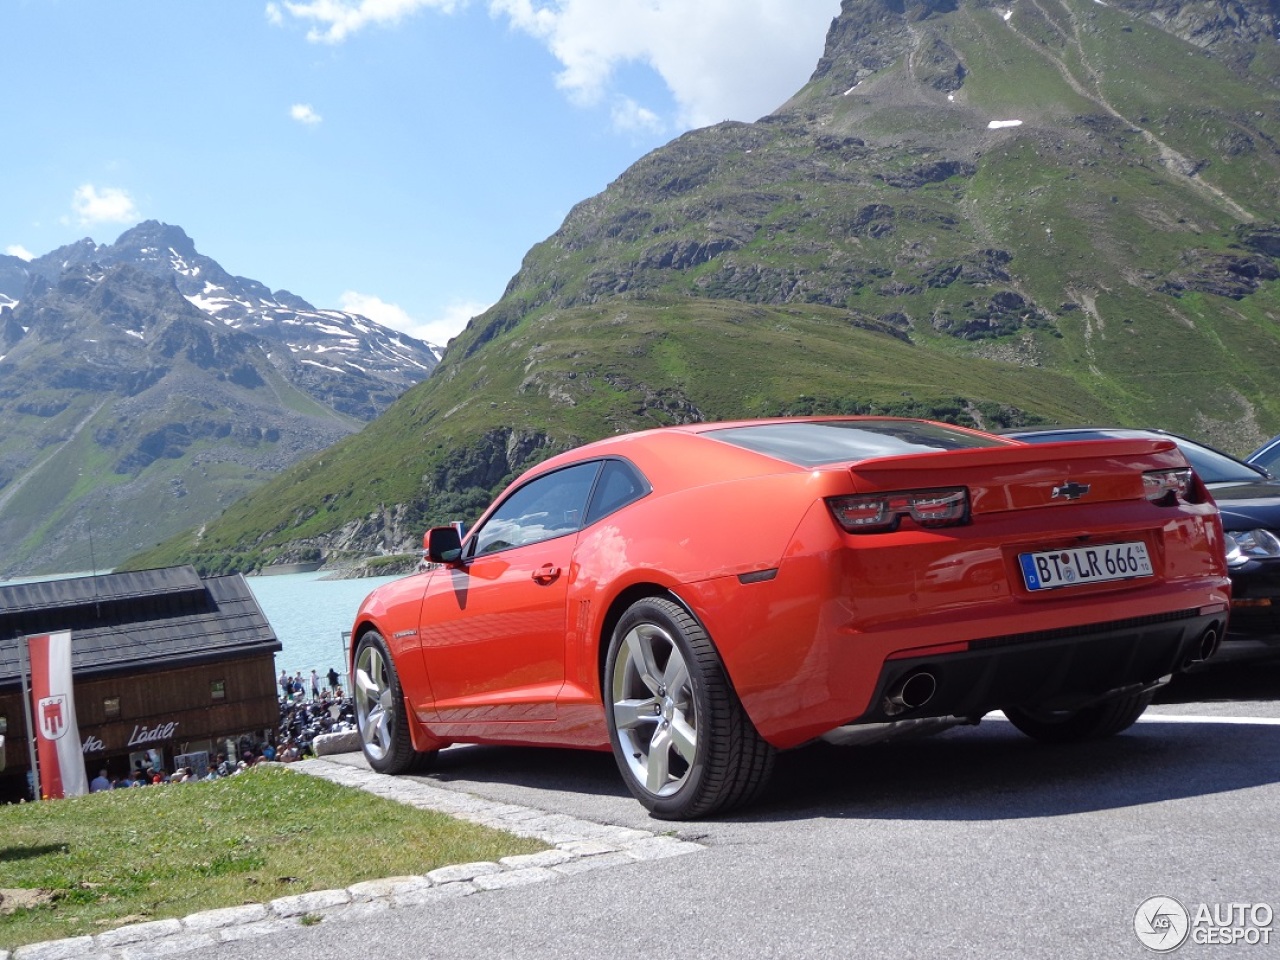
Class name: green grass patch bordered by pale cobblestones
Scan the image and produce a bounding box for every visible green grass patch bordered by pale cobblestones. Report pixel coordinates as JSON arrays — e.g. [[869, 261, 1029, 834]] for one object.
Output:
[[0, 767, 547, 950]]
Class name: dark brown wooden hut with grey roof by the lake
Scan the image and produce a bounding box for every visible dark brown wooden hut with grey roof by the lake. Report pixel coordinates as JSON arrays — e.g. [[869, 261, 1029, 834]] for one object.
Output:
[[0, 567, 280, 801]]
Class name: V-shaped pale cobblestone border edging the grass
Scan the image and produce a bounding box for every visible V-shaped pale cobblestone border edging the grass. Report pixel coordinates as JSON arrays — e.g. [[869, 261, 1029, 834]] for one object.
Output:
[[0, 758, 703, 960]]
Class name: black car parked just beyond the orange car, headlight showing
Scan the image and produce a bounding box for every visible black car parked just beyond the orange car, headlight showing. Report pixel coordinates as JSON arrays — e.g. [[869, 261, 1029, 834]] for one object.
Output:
[[1006, 428, 1280, 659]]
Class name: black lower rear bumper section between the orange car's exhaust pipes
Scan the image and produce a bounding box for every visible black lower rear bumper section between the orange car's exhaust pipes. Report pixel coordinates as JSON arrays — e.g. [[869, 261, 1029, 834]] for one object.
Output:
[[850, 609, 1226, 723]]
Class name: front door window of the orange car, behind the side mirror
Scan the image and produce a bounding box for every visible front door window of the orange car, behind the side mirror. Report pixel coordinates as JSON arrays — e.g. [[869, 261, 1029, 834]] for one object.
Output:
[[472, 461, 600, 556]]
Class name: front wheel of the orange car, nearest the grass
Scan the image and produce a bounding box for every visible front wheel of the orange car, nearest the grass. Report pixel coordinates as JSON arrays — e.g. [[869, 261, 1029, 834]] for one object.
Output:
[[352, 630, 438, 773]]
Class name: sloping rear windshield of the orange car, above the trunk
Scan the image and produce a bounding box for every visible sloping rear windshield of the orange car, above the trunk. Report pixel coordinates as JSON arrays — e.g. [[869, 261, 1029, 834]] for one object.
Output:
[[703, 420, 1007, 467]]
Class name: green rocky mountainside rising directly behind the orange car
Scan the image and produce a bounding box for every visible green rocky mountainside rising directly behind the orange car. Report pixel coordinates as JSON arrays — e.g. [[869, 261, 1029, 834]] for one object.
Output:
[[124, 0, 1280, 578]]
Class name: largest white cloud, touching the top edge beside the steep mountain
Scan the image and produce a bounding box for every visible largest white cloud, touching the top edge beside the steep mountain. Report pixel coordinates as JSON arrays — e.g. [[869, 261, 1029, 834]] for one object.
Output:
[[489, 0, 840, 127]]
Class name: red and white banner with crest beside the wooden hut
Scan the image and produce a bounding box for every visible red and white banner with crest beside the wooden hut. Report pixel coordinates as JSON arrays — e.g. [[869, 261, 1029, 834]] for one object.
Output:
[[27, 630, 88, 800]]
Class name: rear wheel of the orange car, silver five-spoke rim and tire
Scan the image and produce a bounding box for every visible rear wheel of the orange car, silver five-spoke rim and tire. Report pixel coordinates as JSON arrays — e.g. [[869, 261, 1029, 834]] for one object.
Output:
[[604, 598, 774, 820]]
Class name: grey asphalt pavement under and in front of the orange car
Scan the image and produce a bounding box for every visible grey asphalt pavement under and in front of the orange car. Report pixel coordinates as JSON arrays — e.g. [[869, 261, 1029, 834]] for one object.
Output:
[[184, 663, 1280, 960]]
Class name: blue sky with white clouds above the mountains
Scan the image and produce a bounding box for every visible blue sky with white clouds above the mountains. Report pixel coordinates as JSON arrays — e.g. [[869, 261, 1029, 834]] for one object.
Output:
[[0, 0, 840, 344]]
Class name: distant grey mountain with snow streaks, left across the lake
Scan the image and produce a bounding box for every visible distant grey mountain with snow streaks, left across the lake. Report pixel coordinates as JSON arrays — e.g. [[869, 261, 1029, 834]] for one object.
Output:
[[0, 221, 438, 575]]
